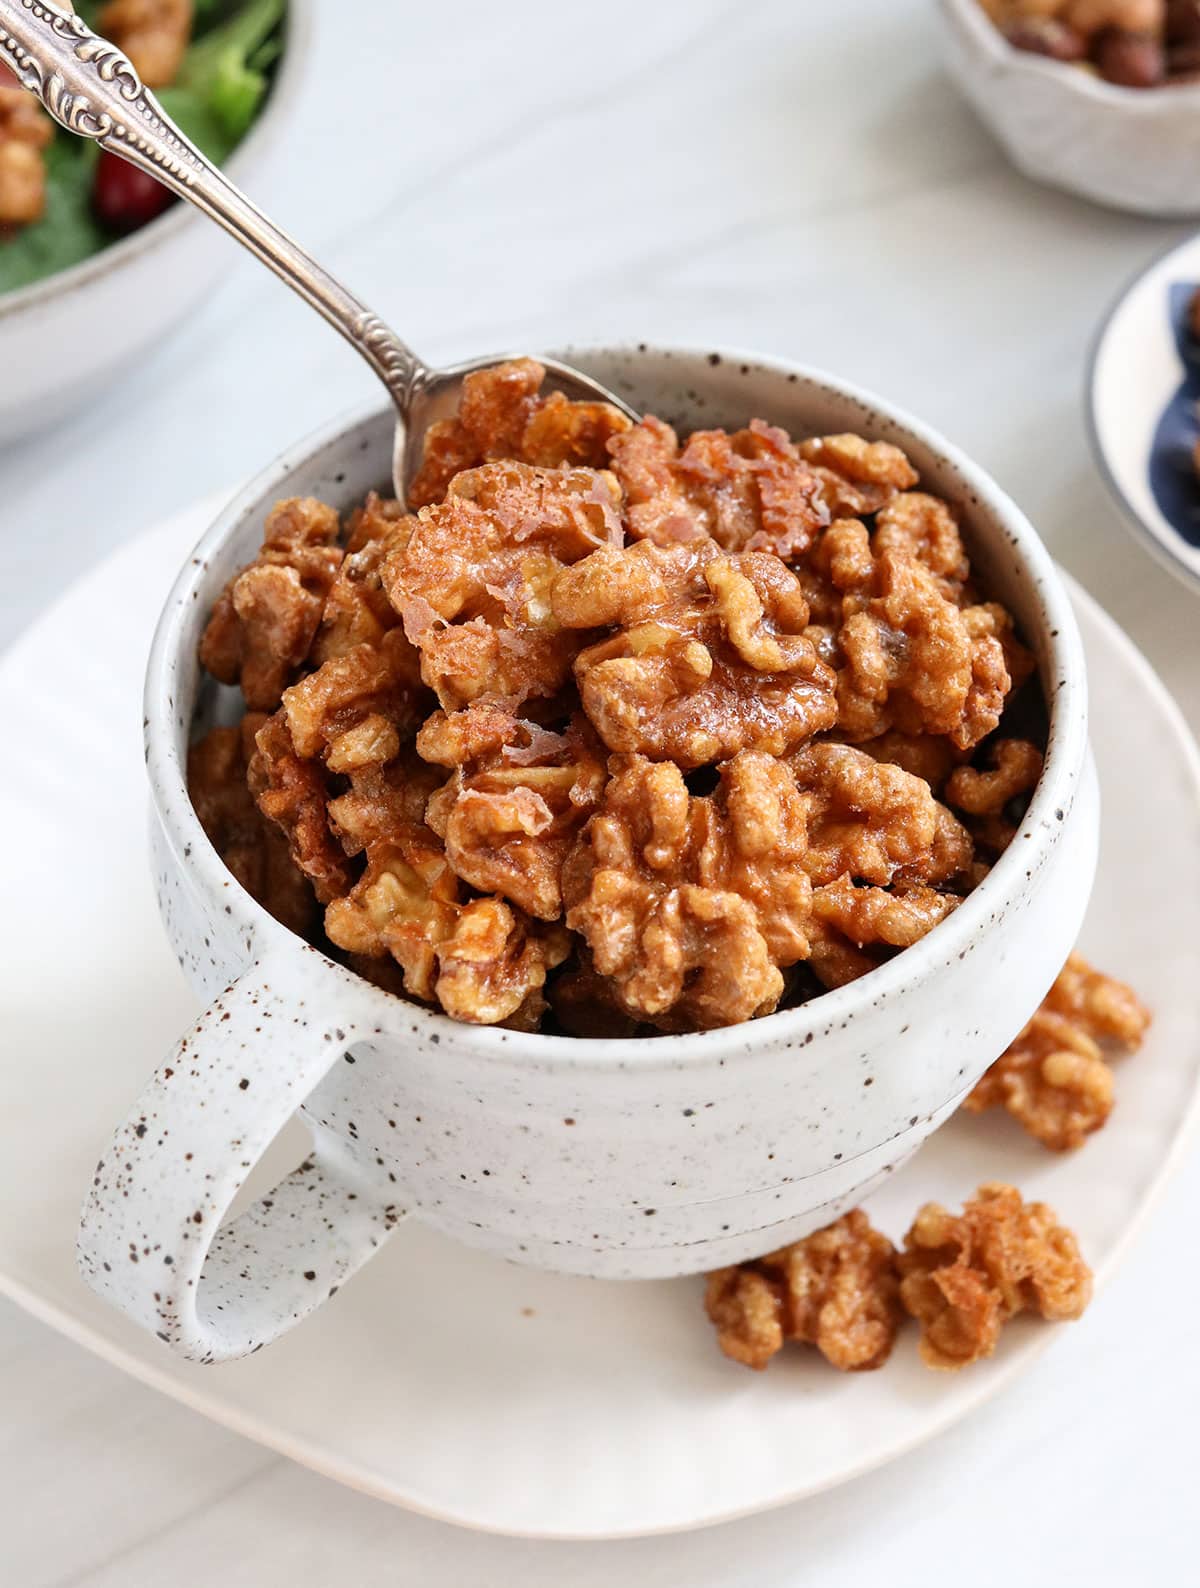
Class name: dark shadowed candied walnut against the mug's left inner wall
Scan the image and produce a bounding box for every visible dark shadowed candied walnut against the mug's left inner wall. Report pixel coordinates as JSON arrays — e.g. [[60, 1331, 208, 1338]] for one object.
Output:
[[187, 715, 316, 937]]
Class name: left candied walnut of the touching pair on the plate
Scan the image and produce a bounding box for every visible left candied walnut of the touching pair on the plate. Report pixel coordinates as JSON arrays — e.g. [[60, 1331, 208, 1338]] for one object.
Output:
[[705, 1208, 903, 1372]]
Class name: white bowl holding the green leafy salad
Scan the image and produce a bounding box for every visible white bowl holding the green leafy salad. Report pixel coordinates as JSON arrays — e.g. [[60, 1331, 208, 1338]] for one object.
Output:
[[0, 0, 313, 445]]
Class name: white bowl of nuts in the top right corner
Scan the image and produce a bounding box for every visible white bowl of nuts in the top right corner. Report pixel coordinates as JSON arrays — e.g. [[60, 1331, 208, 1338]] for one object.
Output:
[[938, 0, 1200, 216]]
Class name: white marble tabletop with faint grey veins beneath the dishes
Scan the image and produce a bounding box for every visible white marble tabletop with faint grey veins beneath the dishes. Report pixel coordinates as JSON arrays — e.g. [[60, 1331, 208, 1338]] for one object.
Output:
[[0, 0, 1200, 1588]]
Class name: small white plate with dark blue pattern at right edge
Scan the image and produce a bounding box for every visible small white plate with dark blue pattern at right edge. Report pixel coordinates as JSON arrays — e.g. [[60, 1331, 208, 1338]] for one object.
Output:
[[1087, 237, 1200, 589]]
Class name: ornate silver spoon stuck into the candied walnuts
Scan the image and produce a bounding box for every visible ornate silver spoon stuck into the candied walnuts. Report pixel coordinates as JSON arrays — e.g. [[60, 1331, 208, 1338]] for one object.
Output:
[[0, 0, 638, 502]]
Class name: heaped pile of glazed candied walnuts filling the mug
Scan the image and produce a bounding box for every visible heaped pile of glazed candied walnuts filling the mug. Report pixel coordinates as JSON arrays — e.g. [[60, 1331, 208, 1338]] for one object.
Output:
[[189, 359, 1043, 1035]]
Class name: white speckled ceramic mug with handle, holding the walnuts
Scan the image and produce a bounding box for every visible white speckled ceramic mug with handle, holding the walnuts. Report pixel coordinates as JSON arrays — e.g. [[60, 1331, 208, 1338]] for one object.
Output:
[[79, 348, 1098, 1361]]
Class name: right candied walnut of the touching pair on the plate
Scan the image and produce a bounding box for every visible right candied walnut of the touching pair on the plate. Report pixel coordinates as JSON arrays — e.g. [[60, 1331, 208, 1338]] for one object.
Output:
[[898, 1183, 1092, 1369]]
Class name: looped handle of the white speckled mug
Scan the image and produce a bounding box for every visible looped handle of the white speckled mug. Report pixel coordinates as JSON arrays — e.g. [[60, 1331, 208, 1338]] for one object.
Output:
[[76, 945, 406, 1363]]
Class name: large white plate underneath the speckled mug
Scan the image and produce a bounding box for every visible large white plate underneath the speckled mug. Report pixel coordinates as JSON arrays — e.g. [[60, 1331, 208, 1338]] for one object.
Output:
[[0, 503, 1200, 1539]]
